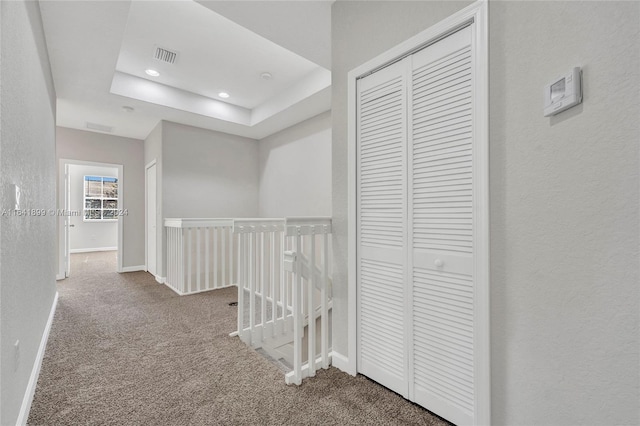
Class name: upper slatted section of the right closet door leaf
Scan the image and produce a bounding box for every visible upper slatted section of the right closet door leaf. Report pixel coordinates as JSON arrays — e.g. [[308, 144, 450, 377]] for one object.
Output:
[[412, 30, 473, 253]]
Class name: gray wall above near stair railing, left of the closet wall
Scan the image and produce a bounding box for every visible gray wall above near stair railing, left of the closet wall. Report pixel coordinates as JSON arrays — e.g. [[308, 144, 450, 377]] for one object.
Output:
[[258, 112, 331, 217]]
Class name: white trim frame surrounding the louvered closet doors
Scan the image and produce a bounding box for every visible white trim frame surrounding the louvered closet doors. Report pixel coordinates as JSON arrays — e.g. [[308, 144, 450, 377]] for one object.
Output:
[[340, 0, 491, 424]]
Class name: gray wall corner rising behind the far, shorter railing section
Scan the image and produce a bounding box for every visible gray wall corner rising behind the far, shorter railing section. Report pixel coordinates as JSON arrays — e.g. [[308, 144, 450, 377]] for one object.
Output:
[[151, 121, 259, 277]]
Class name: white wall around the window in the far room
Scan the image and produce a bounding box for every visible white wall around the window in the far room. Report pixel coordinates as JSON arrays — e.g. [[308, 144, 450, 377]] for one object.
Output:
[[69, 164, 118, 251]]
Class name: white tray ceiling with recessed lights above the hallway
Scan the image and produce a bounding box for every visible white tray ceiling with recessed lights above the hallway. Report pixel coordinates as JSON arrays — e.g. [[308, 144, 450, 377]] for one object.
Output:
[[40, 0, 332, 139]]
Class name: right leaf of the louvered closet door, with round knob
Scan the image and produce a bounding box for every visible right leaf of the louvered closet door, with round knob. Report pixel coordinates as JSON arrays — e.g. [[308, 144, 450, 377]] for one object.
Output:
[[409, 27, 474, 424]]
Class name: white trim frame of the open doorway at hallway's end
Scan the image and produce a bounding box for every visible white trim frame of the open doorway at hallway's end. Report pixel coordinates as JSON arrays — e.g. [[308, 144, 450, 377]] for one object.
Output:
[[56, 158, 124, 279]]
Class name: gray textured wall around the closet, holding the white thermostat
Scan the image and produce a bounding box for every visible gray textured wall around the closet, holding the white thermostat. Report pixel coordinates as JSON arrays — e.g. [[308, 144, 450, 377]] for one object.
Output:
[[332, 2, 640, 425]]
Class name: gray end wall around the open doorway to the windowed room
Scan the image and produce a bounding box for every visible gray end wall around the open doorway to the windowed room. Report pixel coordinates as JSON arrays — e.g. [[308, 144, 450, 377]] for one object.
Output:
[[56, 127, 145, 270]]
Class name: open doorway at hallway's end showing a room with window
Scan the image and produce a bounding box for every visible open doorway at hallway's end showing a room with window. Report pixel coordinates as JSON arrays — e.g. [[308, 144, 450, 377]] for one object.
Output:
[[56, 159, 124, 279]]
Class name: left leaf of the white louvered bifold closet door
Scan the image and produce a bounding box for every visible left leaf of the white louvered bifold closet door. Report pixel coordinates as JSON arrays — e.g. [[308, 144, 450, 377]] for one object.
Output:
[[357, 59, 409, 397]]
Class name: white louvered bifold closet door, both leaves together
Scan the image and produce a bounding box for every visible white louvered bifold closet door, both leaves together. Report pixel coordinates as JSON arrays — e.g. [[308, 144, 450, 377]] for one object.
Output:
[[356, 22, 476, 424]]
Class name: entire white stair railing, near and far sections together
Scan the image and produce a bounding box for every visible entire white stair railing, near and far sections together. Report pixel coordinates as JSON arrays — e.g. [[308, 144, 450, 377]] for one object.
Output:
[[165, 218, 331, 385]]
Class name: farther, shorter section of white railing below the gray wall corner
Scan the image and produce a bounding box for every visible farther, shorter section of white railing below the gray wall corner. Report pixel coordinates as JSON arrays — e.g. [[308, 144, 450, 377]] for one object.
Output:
[[164, 219, 236, 295]]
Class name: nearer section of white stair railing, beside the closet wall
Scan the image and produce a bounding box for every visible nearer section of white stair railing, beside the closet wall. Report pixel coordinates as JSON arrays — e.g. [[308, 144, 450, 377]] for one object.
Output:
[[233, 218, 331, 384]]
